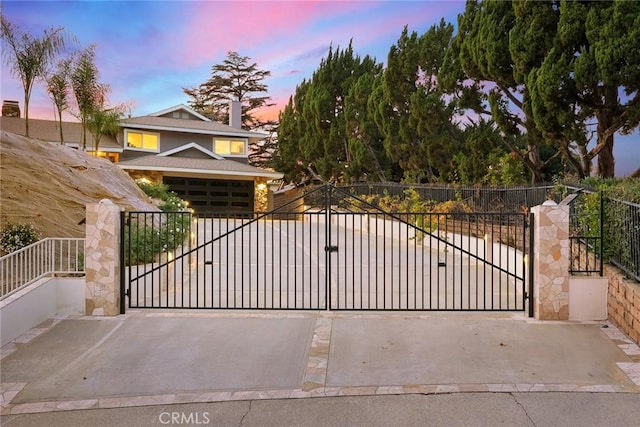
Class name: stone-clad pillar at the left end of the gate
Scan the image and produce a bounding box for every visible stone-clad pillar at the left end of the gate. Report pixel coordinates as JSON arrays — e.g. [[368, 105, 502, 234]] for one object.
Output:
[[85, 199, 120, 316]]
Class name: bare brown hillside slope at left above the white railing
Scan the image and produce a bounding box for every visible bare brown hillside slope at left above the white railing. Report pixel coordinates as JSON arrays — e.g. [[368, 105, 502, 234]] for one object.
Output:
[[0, 131, 158, 241]]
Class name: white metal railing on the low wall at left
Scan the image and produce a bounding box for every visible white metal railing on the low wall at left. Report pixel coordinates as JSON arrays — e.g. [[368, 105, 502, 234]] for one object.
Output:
[[0, 237, 84, 300]]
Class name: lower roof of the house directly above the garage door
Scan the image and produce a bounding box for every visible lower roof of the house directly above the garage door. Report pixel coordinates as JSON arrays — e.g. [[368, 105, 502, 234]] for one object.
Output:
[[117, 154, 283, 179]]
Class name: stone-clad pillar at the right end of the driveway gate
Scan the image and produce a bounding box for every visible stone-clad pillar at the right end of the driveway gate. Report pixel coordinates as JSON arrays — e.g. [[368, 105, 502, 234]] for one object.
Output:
[[531, 201, 569, 320]]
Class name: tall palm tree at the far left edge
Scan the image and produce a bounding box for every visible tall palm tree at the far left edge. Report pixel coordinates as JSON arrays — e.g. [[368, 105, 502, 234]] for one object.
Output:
[[0, 15, 64, 137]]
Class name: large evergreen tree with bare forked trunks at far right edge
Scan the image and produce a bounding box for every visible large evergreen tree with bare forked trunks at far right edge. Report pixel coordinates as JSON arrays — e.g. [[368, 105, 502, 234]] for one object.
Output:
[[529, 1, 640, 177]]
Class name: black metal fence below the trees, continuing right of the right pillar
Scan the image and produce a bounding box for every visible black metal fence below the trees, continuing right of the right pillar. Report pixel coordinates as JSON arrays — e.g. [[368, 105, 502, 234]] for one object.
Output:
[[343, 183, 640, 281]]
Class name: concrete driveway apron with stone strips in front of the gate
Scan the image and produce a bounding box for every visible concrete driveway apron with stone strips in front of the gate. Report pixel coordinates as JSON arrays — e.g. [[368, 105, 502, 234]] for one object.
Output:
[[1, 311, 640, 415]]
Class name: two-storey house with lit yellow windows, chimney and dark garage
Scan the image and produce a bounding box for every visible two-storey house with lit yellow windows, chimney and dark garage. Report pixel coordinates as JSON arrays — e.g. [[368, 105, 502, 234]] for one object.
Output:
[[1, 101, 282, 214]]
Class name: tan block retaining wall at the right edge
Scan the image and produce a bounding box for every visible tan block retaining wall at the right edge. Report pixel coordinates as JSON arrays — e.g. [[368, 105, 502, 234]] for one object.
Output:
[[604, 265, 640, 344]]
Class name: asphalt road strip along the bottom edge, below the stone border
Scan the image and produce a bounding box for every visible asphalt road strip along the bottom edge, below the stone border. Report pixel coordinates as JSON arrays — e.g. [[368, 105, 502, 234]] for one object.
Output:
[[2, 393, 640, 427]]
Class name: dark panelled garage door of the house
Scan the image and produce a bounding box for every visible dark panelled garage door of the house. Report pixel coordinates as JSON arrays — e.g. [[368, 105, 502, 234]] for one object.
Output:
[[163, 176, 254, 214]]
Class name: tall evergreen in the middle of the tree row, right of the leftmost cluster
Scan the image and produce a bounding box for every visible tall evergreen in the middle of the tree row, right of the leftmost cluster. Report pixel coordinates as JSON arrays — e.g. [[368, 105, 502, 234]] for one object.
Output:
[[371, 20, 475, 182]]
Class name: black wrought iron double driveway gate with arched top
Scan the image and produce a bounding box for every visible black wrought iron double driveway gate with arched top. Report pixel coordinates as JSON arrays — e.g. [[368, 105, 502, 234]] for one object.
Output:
[[121, 185, 531, 311]]
